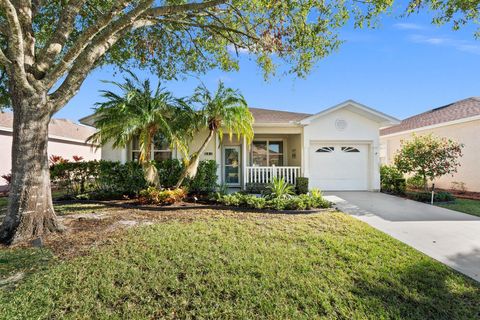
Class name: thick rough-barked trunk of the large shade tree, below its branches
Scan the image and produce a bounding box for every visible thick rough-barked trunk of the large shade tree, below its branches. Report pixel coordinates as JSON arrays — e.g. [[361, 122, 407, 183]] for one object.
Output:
[[0, 95, 63, 244]]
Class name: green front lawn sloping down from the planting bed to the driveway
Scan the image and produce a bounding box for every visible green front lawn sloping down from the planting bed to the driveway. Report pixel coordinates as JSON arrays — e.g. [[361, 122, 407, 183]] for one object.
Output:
[[0, 211, 480, 319]]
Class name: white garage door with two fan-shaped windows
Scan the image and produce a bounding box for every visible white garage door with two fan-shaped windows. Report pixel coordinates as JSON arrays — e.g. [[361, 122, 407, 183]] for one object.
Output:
[[309, 143, 369, 190]]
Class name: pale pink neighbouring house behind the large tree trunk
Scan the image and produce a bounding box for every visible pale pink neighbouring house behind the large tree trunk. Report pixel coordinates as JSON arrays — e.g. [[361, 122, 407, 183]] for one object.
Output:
[[0, 112, 101, 189]]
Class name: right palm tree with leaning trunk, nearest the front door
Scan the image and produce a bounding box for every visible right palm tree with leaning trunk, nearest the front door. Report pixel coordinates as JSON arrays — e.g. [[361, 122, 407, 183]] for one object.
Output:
[[176, 82, 253, 188]]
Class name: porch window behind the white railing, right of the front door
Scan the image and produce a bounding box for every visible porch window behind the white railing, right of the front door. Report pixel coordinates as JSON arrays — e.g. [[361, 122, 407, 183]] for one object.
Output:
[[251, 140, 284, 167]]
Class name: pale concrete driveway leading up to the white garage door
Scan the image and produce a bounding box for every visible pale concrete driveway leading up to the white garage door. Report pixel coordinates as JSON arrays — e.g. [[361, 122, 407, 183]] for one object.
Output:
[[325, 192, 480, 281]]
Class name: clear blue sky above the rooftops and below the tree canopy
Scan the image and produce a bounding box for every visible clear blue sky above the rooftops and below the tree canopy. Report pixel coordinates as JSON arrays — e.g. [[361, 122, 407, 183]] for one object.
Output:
[[55, 9, 480, 121]]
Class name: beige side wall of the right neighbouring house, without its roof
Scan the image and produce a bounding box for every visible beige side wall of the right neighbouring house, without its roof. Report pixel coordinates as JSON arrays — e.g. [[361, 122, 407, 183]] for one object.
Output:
[[380, 120, 480, 192]]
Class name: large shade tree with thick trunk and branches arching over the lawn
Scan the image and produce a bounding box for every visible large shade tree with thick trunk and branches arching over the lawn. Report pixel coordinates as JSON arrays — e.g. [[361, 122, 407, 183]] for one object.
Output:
[[0, 0, 478, 243]]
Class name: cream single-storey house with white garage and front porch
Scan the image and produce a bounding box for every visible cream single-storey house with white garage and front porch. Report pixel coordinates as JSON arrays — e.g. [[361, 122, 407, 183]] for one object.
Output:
[[80, 100, 399, 190]]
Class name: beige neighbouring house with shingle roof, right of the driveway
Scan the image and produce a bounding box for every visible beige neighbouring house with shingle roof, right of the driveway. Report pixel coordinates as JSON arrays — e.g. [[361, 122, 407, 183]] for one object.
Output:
[[380, 97, 480, 192]]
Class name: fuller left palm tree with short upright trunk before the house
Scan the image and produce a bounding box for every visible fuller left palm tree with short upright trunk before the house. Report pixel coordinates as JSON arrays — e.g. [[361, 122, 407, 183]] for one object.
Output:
[[88, 71, 194, 186]]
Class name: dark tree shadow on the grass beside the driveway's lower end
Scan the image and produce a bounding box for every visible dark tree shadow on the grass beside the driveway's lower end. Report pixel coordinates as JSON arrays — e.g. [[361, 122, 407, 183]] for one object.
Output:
[[351, 261, 480, 320]]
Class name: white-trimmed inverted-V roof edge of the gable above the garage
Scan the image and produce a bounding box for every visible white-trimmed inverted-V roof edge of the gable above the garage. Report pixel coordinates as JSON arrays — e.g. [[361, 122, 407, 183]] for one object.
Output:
[[300, 100, 400, 127]]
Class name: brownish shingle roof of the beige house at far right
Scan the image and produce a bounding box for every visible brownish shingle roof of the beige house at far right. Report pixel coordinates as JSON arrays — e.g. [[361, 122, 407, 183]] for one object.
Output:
[[380, 97, 480, 136]]
